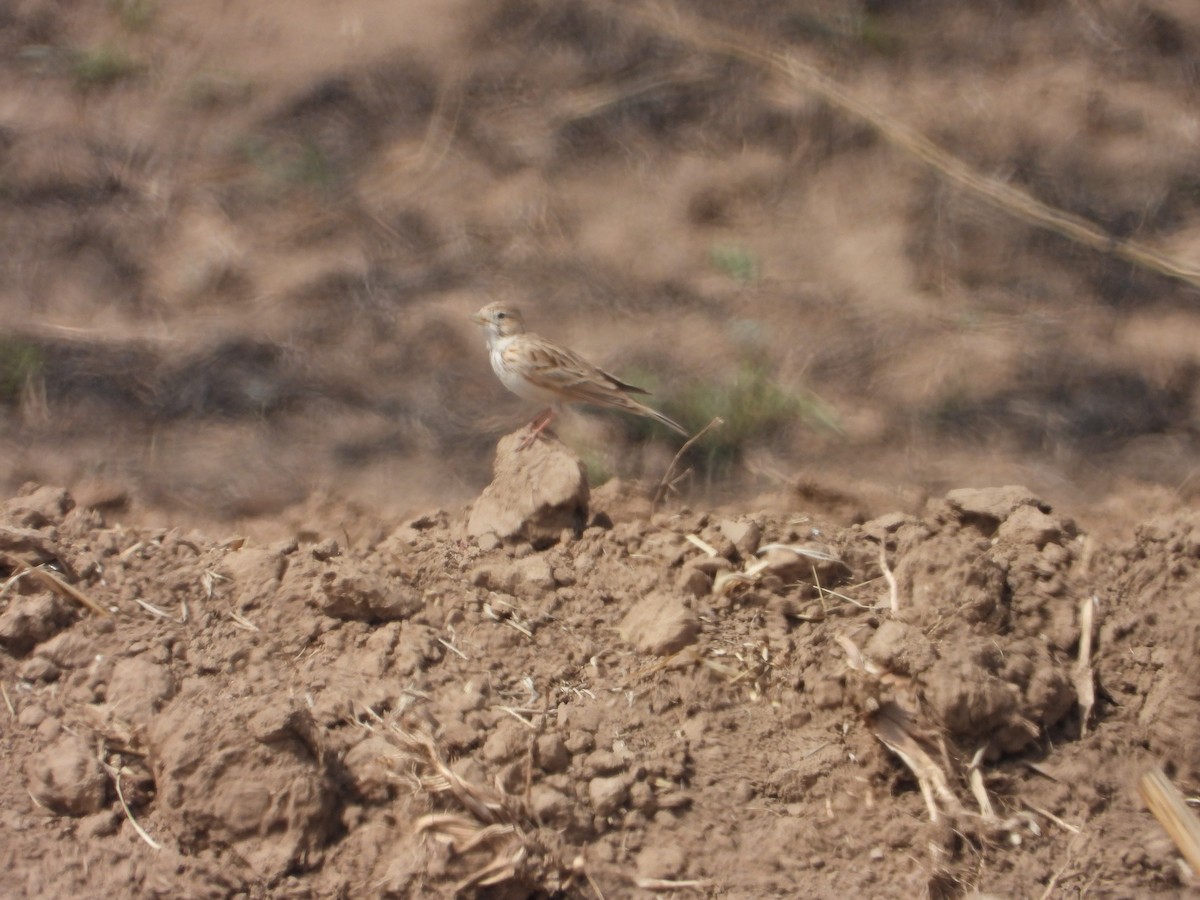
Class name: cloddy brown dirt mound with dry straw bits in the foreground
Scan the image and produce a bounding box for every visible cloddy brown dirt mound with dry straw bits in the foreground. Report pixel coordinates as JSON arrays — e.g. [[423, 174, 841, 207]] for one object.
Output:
[[0, 468, 1200, 898]]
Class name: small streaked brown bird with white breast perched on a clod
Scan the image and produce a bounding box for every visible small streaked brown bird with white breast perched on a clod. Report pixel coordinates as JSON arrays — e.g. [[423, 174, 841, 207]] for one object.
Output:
[[472, 301, 688, 450]]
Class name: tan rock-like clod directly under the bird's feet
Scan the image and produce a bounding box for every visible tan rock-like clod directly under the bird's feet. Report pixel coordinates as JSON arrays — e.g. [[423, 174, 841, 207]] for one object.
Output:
[[467, 430, 589, 547]]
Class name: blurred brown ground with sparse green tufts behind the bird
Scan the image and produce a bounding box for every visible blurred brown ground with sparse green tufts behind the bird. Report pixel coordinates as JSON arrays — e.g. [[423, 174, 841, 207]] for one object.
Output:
[[0, 0, 1200, 518]]
